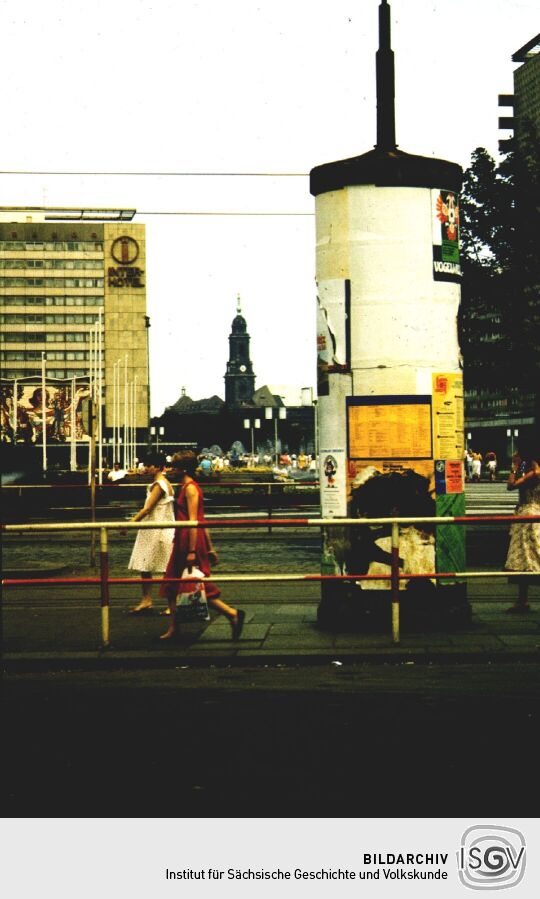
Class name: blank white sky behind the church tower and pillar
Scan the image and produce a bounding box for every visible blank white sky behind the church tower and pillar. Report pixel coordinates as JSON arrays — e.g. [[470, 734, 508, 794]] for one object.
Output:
[[0, 0, 538, 414]]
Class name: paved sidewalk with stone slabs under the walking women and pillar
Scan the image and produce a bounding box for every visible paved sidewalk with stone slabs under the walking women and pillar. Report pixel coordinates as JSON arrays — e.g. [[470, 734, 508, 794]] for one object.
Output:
[[3, 578, 540, 671]]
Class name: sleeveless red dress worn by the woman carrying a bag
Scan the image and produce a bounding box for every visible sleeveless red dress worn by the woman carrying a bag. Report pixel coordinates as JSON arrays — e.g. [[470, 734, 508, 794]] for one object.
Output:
[[160, 481, 221, 600]]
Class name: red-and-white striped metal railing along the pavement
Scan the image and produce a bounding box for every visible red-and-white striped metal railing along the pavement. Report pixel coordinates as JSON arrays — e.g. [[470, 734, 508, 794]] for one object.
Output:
[[2, 515, 540, 648]]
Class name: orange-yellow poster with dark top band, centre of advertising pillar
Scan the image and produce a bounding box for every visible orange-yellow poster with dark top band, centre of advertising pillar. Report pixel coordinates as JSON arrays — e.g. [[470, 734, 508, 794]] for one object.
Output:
[[347, 396, 432, 459]]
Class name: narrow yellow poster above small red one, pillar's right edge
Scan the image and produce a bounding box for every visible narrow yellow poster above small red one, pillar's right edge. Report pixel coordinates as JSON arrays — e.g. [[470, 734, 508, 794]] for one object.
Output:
[[432, 372, 464, 460]]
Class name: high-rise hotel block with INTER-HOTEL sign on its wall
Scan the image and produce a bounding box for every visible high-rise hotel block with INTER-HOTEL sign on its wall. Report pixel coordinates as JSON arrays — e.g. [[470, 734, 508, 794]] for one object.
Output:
[[0, 207, 149, 440]]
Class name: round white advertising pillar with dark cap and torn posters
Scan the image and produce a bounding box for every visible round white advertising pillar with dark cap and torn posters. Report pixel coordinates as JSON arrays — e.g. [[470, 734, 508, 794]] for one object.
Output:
[[311, 148, 468, 624]]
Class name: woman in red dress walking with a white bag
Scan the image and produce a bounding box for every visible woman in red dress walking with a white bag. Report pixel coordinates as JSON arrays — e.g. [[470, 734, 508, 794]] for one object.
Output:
[[161, 452, 246, 640]]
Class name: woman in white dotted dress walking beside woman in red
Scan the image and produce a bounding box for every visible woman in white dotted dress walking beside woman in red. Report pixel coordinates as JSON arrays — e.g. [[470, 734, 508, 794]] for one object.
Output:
[[128, 453, 174, 615]]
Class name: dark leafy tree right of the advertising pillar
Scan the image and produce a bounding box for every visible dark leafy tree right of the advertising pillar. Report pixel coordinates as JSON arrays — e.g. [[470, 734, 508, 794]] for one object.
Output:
[[460, 135, 540, 404]]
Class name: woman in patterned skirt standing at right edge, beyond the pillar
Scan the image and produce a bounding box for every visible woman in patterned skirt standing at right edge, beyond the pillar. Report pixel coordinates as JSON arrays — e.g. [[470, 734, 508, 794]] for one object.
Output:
[[505, 444, 540, 614]]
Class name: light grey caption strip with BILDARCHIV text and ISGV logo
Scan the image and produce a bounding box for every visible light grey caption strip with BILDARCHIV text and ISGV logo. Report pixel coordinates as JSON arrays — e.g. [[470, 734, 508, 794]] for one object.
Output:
[[0, 820, 540, 899]]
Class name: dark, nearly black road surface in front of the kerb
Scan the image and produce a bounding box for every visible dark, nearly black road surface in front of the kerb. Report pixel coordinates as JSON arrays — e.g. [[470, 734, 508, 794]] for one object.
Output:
[[2, 664, 540, 817]]
